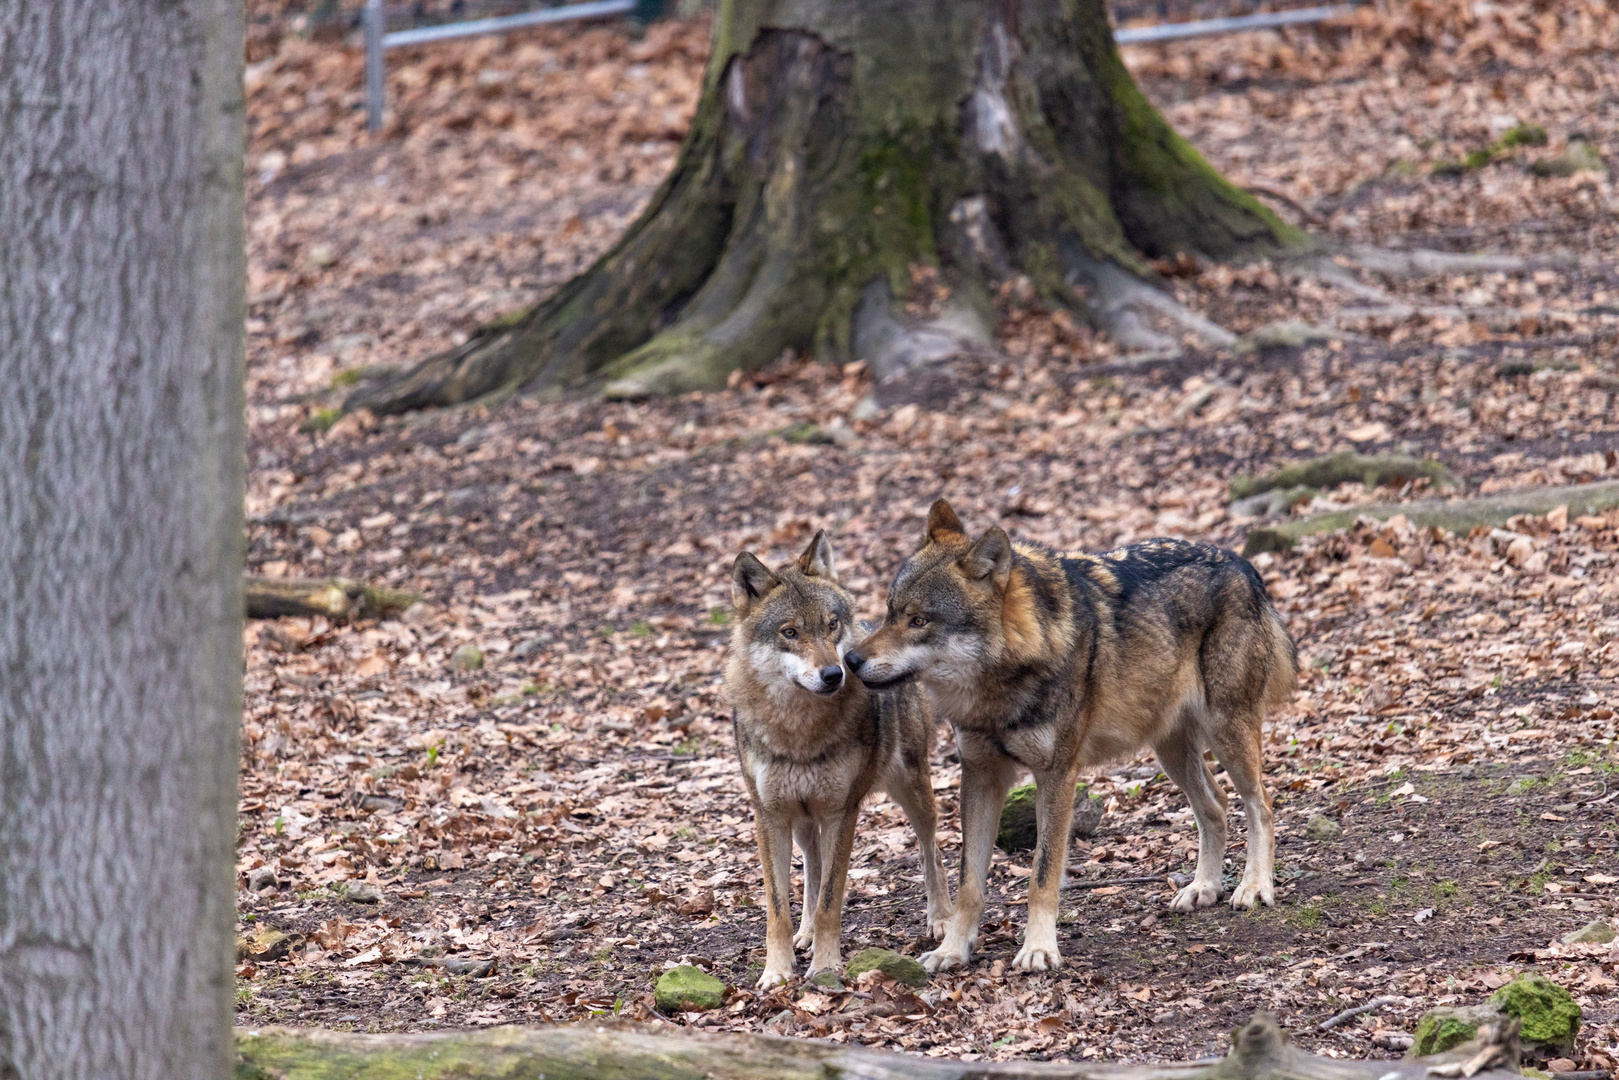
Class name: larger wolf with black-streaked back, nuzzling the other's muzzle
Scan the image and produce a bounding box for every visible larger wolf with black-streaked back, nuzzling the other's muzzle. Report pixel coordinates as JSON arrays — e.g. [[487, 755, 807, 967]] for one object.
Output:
[[847, 499, 1298, 972]]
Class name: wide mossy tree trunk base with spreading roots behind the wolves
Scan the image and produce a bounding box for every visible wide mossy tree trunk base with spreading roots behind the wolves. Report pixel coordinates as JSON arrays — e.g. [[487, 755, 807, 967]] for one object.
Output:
[[348, 0, 1305, 413]]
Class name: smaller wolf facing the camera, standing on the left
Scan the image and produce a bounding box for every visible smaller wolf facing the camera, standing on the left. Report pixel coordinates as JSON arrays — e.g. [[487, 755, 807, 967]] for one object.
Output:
[[725, 533, 950, 989]]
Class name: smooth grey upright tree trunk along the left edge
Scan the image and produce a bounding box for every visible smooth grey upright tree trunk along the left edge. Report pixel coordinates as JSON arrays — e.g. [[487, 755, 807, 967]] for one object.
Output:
[[0, 0, 246, 1080]]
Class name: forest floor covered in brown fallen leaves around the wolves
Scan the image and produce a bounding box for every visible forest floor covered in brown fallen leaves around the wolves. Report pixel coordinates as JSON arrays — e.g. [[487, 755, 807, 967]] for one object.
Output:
[[238, 0, 1619, 1069]]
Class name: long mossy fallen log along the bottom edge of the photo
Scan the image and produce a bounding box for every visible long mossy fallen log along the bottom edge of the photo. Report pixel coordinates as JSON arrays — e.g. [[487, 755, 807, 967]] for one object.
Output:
[[236, 1014, 1519, 1080]]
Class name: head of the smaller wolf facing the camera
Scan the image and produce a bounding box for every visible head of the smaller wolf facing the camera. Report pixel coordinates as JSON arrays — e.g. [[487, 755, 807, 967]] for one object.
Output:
[[730, 529, 855, 698]]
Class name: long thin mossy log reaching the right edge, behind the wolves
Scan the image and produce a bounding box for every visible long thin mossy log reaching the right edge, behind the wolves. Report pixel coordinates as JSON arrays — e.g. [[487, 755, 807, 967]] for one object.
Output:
[[1242, 481, 1619, 557]]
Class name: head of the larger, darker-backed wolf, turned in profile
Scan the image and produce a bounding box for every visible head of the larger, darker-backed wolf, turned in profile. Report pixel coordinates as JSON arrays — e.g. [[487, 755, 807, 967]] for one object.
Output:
[[845, 499, 1012, 693]]
